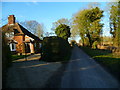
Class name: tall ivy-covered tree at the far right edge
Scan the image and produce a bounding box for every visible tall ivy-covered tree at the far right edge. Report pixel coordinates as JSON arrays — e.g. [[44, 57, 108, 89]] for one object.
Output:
[[109, 1, 120, 47]]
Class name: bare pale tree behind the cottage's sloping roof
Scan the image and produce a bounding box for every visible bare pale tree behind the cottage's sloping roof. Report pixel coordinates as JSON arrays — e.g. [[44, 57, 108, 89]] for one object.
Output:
[[20, 20, 44, 38]]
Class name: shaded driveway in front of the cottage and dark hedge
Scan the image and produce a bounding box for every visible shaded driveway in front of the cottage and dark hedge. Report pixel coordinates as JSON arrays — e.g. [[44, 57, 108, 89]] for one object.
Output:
[[6, 54, 61, 88]]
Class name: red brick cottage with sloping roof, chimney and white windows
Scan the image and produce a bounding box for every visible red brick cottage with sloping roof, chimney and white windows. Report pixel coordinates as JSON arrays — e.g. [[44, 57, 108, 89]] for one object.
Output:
[[2, 15, 42, 54]]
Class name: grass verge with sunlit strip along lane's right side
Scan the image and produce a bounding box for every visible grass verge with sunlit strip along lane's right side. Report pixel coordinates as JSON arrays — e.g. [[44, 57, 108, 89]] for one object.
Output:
[[80, 47, 120, 81]]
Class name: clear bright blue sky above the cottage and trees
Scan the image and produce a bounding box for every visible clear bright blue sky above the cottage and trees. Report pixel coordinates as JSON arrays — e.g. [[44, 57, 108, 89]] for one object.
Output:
[[0, 1, 113, 41]]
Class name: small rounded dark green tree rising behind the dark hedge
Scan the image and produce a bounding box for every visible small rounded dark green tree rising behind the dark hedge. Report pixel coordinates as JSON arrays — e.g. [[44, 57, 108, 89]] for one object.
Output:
[[55, 24, 71, 40]]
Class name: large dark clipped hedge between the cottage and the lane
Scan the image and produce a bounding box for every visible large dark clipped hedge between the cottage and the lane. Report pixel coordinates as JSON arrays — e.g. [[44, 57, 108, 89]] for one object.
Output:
[[41, 36, 71, 62]]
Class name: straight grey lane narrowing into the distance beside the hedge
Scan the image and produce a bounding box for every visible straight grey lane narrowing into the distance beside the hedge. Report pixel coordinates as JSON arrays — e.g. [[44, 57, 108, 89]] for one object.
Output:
[[61, 46, 119, 88]]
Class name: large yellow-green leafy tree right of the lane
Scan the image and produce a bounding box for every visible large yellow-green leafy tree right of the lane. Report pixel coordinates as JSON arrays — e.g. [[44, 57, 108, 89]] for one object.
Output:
[[73, 7, 103, 47]]
